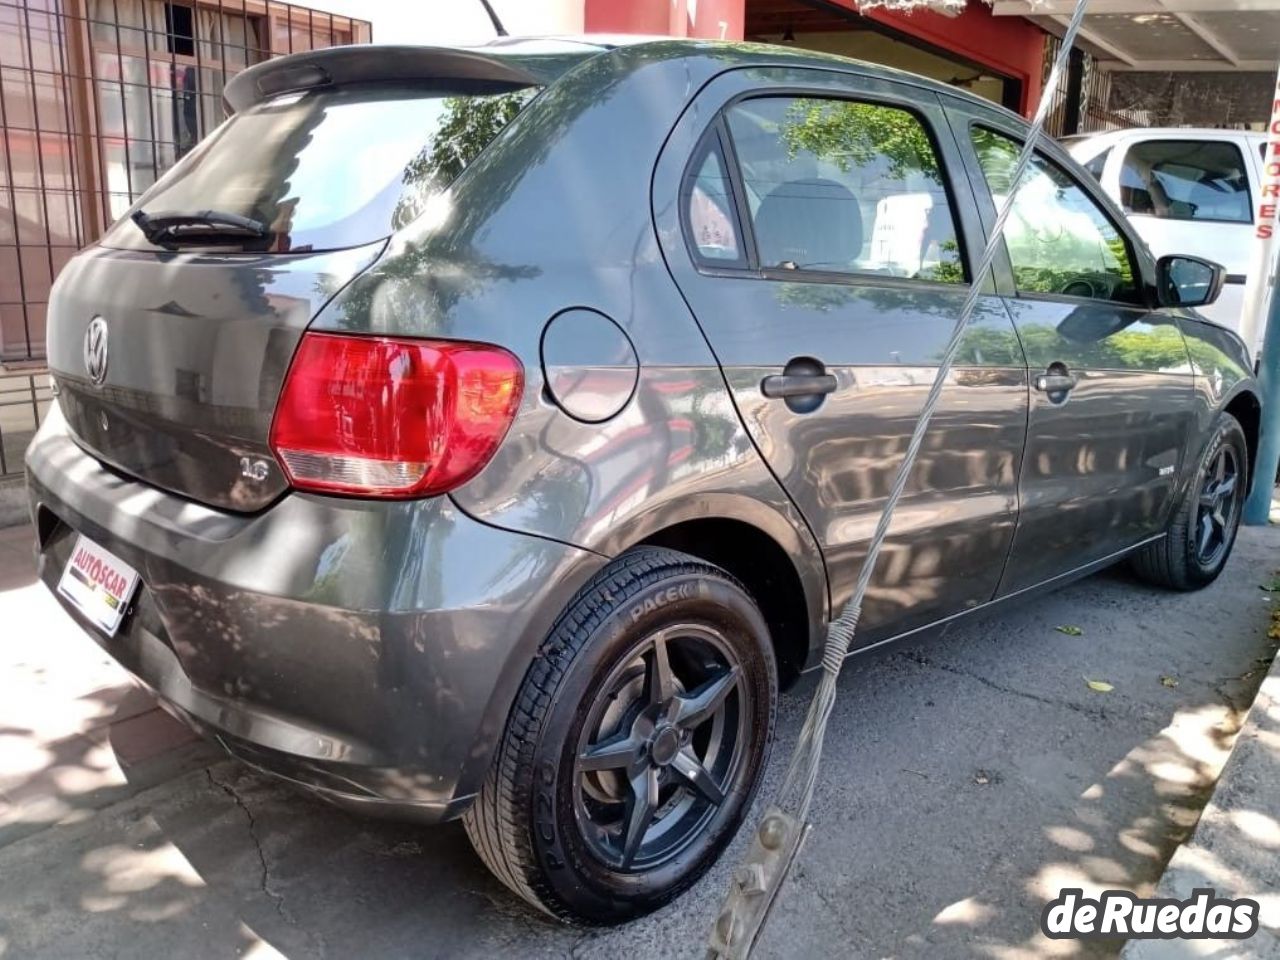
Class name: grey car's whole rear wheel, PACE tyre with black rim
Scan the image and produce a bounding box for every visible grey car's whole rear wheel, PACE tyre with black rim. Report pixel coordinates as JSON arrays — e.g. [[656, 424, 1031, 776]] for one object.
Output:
[[463, 548, 778, 925]]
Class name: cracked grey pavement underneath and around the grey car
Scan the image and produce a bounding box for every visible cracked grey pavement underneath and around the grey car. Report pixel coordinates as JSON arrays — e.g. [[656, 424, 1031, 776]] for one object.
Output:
[[0, 519, 1280, 960]]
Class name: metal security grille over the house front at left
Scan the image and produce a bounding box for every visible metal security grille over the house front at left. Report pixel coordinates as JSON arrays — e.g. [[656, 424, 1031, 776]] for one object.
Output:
[[0, 0, 371, 363]]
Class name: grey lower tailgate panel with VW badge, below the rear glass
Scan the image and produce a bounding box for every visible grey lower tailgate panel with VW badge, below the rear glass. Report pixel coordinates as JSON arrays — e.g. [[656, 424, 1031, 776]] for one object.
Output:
[[49, 242, 384, 511]]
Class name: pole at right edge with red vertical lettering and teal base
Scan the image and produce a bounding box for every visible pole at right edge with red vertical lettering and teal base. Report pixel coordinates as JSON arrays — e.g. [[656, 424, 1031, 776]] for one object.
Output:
[[1243, 64, 1280, 526]]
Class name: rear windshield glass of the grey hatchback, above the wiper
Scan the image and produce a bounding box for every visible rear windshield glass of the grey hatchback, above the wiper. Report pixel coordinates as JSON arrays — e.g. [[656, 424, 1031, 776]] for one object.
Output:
[[104, 83, 538, 252]]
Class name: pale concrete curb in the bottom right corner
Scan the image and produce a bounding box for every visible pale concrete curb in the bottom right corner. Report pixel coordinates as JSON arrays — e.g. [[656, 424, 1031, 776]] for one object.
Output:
[[1120, 658, 1280, 960]]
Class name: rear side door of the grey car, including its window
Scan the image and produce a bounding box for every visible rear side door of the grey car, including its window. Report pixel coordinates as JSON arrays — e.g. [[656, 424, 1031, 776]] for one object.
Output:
[[655, 69, 1027, 645]]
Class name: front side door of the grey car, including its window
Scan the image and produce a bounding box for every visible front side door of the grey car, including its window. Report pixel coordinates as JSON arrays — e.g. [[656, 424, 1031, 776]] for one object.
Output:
[[950, 100, 1194, 595]]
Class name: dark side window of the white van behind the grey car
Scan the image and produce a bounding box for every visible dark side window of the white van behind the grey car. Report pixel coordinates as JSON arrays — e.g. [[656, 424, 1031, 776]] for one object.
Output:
[[1120, 140, 1253, 223]]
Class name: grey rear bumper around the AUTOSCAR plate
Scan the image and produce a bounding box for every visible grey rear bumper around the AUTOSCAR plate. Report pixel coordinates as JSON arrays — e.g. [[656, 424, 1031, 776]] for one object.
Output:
[[27, 408, 604, 820]]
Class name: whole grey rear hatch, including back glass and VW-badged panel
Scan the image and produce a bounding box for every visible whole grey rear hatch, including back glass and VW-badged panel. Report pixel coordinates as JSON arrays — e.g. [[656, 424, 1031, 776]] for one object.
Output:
[[49, 56, 539, 512]]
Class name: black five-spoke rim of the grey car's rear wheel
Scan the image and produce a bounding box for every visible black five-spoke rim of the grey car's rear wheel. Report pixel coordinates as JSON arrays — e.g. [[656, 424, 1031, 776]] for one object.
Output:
[[573, 623, 753, 873]]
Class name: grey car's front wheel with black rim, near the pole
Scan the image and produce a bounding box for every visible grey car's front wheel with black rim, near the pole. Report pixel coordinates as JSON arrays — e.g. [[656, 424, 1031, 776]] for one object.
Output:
[[1130, 413, 1249, 590]]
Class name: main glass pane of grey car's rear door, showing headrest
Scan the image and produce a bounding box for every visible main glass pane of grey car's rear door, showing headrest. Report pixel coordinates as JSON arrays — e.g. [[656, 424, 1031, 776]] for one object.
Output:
[[728, 97, 965, 283]]
